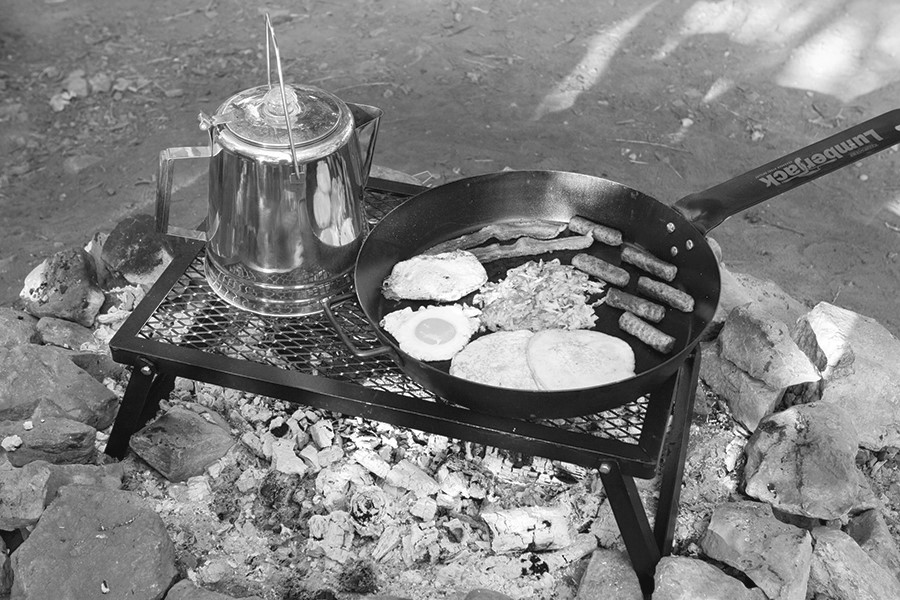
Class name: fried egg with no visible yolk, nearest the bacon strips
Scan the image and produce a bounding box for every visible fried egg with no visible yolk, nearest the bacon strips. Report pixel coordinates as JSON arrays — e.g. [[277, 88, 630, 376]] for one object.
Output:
[[382, 250, 488, 302]]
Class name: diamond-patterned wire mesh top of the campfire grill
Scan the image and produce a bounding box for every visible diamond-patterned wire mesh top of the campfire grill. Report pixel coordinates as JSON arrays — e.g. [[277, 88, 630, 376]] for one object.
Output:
[[138, 191, 648, 445]]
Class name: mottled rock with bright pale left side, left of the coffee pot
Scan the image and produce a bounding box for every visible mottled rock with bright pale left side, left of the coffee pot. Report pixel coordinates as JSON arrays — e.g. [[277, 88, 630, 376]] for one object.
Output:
[[19, 249, 106, 327]]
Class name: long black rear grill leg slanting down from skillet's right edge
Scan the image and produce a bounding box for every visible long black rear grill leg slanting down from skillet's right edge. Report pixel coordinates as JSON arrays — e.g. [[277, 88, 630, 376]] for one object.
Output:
[[654, 350, 700, 556]]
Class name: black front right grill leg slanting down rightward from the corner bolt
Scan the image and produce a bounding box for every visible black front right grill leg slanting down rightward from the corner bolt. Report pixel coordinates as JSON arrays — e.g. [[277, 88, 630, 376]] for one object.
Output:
[[600, 461, 660, 595]]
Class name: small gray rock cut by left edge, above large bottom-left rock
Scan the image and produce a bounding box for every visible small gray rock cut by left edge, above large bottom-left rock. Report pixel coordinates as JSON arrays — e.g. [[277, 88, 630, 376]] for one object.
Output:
[[0, 462, 51, 531]]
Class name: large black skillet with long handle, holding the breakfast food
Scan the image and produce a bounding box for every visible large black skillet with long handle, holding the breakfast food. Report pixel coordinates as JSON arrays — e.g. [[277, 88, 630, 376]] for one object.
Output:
[[326, 109, 900, 418]]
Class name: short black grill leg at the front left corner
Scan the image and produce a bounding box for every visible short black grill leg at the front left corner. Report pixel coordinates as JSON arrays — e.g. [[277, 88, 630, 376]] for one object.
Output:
[[105, 360, 175, 459]]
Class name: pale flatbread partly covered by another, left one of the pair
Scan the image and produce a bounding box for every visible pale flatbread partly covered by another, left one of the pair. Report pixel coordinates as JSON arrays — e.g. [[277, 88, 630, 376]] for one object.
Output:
[[450, 330, 540, 390]]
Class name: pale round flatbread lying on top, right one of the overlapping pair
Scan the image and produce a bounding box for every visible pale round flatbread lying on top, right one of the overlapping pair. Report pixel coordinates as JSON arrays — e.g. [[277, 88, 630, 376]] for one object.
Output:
[[525, 329, 634, 390]]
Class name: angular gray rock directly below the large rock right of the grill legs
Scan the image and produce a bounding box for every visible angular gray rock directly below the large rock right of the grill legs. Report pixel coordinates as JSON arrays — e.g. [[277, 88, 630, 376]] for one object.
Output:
[[701, 501, 812, 600]]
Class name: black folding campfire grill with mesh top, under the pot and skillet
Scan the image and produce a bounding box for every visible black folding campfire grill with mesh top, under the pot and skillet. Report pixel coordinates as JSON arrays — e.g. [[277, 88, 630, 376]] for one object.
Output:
[[106, 178, 699, 592]]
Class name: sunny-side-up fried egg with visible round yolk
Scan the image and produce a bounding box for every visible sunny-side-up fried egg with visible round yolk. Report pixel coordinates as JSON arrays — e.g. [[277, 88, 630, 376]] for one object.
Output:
[[381, 304, 481, 362]]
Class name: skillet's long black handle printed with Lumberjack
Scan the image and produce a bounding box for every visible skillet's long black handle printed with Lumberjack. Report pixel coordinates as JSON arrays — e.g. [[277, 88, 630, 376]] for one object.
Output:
[[672, 109, 900, 235]]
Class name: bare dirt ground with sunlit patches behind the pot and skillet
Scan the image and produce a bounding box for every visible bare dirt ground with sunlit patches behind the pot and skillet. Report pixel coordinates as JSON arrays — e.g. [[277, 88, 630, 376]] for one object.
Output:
[[0, 0, 900, 335]]
